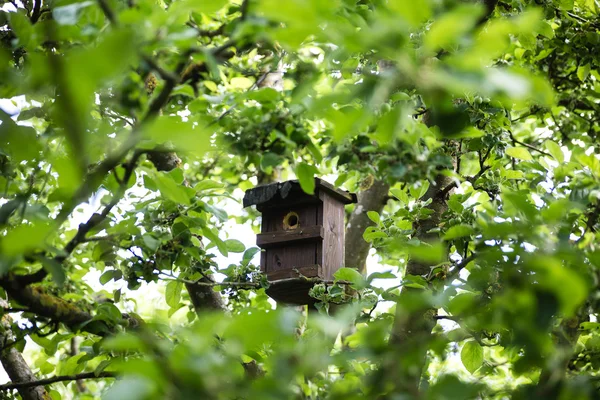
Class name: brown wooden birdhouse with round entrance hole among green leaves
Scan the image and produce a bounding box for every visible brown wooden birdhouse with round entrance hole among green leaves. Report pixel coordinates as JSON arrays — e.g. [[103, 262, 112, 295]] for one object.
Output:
[[244, 178, 356, 304]]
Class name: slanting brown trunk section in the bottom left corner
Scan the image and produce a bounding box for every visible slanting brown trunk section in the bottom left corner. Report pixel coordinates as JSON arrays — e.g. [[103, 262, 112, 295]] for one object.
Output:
[[0, 300, 50, 400]]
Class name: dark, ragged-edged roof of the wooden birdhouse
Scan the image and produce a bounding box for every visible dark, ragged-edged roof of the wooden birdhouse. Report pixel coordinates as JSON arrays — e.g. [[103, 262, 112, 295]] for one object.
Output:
[[244, 178, 356, 207]]
